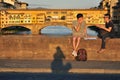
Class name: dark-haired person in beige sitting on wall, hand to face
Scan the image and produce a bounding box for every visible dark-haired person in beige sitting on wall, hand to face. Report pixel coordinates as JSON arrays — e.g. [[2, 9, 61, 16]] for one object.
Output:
[[72, 13, 87, 56]]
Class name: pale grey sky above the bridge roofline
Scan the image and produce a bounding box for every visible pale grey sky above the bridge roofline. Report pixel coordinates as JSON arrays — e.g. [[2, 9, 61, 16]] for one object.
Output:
[[19, 0, 101, 9]]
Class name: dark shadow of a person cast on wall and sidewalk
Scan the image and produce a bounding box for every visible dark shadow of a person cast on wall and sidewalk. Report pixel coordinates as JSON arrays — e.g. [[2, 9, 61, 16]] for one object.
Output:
[[51, 46, 72, 73]]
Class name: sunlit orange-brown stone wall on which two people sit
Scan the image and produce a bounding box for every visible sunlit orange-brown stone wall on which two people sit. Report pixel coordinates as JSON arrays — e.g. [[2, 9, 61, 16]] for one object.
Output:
[[0, 35, 120, 61]]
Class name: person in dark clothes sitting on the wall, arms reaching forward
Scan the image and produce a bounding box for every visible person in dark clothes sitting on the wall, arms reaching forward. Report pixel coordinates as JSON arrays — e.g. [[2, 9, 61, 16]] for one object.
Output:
[[96, 14, 114, 53]]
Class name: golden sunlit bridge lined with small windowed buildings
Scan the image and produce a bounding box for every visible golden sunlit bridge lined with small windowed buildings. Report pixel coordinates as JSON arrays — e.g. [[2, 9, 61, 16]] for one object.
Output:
[[0, 9, 107, 34]]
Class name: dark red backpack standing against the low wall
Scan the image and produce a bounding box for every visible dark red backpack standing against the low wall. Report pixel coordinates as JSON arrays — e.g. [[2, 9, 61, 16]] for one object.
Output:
[[75, 49, 87, 61]]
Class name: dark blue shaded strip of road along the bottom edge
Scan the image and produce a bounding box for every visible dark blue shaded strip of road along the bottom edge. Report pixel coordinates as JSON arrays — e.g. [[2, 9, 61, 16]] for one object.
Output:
[[0, 72, 120, 80]]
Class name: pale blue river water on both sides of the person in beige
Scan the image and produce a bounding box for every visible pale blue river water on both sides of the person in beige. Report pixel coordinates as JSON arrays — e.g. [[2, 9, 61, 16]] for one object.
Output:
[[41, 26, 97, 36]]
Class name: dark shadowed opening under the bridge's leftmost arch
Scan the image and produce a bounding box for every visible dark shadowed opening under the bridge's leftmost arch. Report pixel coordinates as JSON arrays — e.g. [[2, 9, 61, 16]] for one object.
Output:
[[1, 26, 31, 34]]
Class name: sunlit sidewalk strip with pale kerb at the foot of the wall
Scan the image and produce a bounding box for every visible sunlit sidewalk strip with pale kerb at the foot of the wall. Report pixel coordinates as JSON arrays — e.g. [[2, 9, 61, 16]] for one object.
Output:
[[0, 59, 120, 74]]
